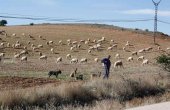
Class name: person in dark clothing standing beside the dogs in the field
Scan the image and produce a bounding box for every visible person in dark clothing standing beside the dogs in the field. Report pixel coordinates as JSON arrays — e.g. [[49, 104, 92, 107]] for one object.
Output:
[[101, 55, 111, 79]]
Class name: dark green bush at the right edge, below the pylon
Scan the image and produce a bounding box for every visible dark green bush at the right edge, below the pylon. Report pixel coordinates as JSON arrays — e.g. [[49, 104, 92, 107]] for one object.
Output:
[[156, 55, 170, 72]]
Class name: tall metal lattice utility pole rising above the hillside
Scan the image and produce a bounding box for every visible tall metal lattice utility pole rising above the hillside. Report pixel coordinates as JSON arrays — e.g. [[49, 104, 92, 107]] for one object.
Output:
[[152, 0, 161, 44]]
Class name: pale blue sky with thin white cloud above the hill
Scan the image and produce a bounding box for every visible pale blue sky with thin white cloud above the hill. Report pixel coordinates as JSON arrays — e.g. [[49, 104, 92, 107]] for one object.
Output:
[[0, 0, 170, 35]]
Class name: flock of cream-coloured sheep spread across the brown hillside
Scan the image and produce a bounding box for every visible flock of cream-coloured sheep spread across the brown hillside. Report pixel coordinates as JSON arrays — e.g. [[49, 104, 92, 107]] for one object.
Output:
[[0, 30, 170, 72]]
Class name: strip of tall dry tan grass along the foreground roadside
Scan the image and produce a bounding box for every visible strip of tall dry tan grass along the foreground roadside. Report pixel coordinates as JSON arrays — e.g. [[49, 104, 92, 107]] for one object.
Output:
[[0, 72, 169, 110]]
